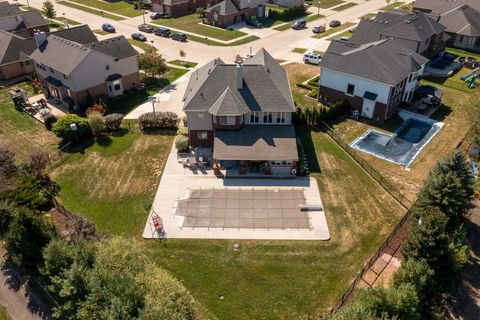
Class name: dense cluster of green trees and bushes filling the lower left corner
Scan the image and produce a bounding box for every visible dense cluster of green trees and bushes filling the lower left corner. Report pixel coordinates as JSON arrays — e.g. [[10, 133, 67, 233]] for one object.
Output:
[[0, 148, 200, 320]]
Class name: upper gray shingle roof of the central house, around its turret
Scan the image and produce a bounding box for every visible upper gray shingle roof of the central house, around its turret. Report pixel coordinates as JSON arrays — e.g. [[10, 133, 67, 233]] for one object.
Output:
[[183, 49, 295, 112]]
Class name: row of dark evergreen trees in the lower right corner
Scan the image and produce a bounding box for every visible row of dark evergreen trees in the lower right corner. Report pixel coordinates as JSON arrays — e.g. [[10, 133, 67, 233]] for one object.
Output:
[[331, 150, 474, 320]]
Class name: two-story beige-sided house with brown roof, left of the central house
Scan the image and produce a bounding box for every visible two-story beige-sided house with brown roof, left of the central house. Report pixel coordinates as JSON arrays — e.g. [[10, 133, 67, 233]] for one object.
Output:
[[31, 32, 140, 110]]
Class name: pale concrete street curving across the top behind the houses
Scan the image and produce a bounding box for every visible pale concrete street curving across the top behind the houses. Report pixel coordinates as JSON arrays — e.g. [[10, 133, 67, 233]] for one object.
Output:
[[18, 0, 404, 64]]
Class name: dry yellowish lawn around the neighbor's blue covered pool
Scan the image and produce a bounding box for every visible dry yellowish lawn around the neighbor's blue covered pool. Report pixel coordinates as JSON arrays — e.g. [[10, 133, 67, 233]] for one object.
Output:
[[328, 85, 469, 200]]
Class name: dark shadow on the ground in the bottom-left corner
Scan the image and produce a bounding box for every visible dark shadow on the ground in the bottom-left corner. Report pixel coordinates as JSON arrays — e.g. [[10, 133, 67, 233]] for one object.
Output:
[[1, 259, 52, 320]]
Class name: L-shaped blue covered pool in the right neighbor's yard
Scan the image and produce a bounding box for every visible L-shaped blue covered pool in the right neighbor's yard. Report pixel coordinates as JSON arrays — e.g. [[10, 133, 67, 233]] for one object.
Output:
[[350, 118, 443, 168]]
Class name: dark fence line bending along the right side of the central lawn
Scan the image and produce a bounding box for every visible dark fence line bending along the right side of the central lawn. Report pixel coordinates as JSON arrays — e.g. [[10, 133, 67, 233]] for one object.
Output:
[[322, 122, 413, 314]]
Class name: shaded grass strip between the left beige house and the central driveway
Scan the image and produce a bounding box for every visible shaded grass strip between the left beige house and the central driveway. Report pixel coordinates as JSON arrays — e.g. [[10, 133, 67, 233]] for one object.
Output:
[[106, 67, 188, 114]]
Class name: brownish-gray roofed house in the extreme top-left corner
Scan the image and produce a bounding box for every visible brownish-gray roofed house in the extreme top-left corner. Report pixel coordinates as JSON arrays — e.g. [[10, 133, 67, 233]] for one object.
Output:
[[0, 5, 50, 36]]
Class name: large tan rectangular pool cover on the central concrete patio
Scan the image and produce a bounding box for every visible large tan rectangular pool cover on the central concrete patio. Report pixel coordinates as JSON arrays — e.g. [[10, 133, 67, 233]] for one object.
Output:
[[175, 188, 310, 229]]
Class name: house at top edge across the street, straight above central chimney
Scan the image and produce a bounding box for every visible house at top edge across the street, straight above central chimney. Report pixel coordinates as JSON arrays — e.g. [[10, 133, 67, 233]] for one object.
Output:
[[205, 0, 266, 28]]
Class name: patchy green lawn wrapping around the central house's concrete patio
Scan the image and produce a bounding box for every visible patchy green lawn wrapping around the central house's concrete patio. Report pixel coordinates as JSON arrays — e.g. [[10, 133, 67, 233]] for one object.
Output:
[[53, 122, 403, 319]]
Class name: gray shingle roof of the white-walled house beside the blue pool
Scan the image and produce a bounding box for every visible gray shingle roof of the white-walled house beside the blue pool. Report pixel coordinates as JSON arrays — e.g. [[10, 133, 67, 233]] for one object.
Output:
[[320, 38, 428, 85]]
